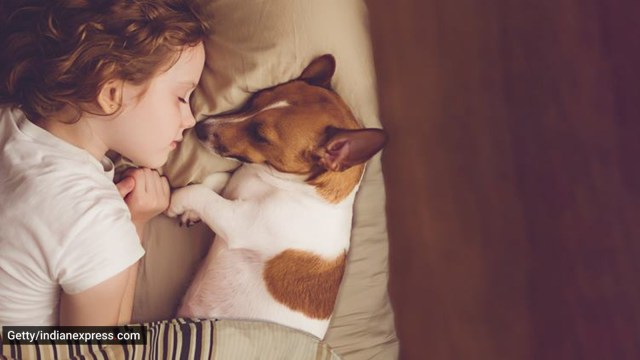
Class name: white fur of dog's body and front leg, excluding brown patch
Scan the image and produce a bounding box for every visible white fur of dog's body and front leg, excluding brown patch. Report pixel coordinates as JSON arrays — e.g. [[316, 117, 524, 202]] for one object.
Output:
[[168, 164, 357, 338]]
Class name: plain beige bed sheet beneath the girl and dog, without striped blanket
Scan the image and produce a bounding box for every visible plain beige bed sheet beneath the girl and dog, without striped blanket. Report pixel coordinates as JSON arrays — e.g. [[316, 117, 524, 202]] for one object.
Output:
[[139, 0, 398, 360]]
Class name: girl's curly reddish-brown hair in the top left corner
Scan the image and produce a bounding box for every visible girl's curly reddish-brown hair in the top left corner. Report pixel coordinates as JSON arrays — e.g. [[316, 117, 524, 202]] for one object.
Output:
[[0, 0, 208, 122]]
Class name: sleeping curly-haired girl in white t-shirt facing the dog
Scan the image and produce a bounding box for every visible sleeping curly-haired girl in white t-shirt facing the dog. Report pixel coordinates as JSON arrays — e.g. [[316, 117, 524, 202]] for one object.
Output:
[[0, 0, 207, 326]]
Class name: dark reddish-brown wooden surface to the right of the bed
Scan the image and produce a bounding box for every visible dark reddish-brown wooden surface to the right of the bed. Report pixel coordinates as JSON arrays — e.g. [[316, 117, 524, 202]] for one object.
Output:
[[367, 0, 640, 360]]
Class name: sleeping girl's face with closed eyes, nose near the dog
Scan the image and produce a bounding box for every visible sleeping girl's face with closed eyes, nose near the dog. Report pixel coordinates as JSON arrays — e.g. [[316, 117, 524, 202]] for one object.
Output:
[[106, 44, 205, 169]]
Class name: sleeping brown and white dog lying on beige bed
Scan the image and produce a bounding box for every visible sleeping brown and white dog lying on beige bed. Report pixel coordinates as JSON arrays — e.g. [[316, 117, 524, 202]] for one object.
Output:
[[168, 55, 386, 338]]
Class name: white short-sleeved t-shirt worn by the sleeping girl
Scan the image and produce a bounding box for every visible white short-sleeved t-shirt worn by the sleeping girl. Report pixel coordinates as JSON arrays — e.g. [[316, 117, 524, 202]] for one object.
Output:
[[0, 108, 144, 327]]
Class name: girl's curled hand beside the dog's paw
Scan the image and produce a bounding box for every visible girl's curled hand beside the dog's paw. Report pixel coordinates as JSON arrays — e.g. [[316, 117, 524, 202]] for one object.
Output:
[[116, 168, 170, 226]]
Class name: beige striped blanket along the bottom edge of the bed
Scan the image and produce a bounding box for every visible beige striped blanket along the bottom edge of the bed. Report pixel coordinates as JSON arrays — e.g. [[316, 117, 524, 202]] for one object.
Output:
[[0, 319, 340, 360]]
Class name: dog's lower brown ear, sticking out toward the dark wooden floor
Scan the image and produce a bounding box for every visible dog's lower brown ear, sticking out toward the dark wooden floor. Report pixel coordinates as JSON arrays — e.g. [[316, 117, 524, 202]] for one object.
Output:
[[318, 128, 387, 171]]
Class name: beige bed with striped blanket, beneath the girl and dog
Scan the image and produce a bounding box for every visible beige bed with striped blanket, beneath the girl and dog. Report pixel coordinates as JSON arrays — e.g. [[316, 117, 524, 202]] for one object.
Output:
[[3, 0, 398, 360]]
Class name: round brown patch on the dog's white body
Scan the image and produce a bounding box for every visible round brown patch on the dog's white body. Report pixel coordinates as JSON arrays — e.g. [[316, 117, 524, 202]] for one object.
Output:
[[263, 250, 347, 320]]
